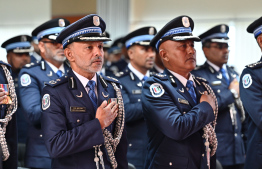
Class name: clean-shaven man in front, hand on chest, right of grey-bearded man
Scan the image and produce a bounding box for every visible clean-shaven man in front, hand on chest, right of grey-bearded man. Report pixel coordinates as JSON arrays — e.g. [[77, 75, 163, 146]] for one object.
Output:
[[142, 15, 217, 169]]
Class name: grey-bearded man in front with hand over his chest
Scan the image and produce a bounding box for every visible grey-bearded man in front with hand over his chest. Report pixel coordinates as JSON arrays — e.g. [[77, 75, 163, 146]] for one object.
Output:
[[42, 14, 128, 169]]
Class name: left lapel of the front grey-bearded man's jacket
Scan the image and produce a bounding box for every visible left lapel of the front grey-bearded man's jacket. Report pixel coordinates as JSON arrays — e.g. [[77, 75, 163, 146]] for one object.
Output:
[[68, 70, 96, 118]]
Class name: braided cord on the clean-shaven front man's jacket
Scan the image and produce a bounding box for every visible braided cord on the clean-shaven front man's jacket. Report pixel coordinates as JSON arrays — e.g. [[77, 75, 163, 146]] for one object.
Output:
[[202, 82, 218, 156]]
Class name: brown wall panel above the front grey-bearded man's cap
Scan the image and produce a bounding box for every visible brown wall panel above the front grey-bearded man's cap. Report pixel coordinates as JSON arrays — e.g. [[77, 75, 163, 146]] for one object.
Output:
[[52, 0, 96, 16]]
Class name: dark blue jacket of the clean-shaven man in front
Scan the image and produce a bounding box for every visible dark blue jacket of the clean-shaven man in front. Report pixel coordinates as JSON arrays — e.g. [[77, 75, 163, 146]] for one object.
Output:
[[142, 69, 215, 169]]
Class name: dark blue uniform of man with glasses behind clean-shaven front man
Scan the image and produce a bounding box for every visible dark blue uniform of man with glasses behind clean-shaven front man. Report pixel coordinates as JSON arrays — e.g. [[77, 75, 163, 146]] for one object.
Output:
[[192, 62, 245, 166]]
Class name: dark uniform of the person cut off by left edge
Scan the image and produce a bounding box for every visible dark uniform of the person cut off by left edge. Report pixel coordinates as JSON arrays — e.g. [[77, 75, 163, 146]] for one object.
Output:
[[0, 61, 17, 169]]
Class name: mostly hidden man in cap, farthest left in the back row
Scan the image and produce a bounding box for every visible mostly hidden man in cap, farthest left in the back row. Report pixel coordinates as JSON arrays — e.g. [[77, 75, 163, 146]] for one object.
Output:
[[2, 35, 32, 167]]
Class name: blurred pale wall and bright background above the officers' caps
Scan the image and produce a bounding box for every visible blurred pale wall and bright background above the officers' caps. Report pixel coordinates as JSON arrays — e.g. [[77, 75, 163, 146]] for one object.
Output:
[[0, 0, 262, 73]]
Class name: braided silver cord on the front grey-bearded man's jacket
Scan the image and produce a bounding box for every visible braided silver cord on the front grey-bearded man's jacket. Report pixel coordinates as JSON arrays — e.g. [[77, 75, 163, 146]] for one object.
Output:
[[103, 82, 125, 169]]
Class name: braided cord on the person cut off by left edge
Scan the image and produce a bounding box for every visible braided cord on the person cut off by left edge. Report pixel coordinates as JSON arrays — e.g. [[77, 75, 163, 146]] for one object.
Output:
[[0, 65, 17, 161]]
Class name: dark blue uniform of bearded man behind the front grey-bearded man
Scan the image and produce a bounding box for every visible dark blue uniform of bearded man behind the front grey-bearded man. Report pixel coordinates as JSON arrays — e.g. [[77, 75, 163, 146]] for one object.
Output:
[[19, 60, 69, 168]]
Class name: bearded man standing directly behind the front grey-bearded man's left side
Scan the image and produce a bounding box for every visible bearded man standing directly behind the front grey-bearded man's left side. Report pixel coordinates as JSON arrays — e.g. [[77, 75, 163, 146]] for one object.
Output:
[[19, 18, 69, 168]]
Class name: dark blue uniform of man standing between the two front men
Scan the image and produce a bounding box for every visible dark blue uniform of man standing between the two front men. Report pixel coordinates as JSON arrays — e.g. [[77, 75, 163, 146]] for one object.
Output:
[[117, 68, 147, 169]]
